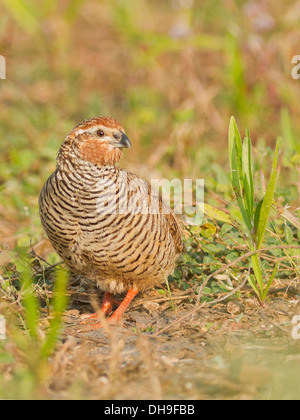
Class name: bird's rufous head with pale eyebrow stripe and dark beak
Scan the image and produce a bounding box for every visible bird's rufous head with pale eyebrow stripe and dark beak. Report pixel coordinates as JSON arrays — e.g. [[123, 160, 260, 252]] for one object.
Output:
[[58, 117, 131, 167]]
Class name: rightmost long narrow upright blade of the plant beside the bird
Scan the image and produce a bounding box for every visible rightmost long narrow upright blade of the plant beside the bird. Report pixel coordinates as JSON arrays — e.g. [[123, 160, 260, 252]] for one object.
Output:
[[256, 140, 280, 249]]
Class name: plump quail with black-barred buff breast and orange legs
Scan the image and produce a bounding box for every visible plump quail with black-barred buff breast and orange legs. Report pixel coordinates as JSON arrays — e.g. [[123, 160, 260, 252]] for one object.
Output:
[[39, 116, 183, 329]]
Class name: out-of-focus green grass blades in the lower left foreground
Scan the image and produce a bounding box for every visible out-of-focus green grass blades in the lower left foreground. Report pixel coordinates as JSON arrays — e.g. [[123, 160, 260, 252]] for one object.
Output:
[[0, 257, 68, 399]]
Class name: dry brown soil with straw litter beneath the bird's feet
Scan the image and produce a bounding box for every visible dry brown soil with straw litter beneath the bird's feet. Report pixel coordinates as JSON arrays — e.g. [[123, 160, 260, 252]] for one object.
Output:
[[44, 284, 300, 400]]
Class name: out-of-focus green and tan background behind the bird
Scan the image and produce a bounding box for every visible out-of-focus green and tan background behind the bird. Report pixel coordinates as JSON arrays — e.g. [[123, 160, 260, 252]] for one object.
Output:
[[0, 0, 300, 254]]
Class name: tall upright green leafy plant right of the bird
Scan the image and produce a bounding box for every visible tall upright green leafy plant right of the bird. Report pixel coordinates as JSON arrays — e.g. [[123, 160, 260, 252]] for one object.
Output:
[[228, 117, 280, 303]]
